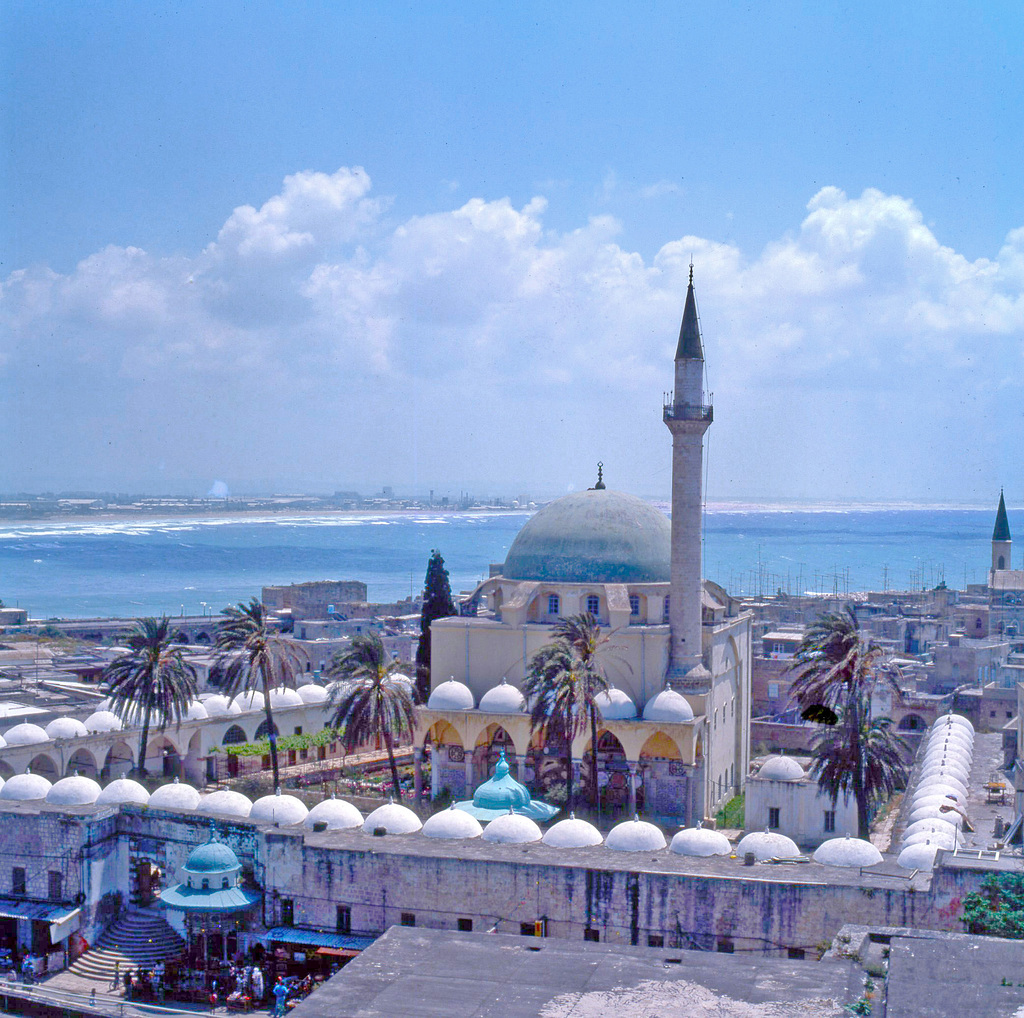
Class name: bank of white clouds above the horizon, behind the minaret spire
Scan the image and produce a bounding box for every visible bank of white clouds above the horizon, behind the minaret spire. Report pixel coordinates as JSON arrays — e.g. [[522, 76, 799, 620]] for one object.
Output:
[[0, 168, 1024, 496]]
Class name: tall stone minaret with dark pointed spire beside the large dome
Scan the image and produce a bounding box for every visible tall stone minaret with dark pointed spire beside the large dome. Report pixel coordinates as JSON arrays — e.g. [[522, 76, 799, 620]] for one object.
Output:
[[665, 264, 714, 681]]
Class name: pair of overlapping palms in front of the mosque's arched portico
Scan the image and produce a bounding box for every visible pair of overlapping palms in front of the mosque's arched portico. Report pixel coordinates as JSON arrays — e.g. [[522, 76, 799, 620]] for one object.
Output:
[[523, 611, 608, 807]]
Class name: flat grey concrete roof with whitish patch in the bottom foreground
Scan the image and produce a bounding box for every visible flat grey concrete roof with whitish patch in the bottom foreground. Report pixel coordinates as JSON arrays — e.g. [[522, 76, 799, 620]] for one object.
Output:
[[292, 926, 861, 1018]]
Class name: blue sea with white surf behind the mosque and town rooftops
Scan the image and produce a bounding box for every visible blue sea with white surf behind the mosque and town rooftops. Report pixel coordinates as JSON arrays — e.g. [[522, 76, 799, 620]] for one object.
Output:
[[0, 503, 1024, 619]]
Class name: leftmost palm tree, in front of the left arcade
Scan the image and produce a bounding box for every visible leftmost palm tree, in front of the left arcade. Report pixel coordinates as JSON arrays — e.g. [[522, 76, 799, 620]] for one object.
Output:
[[103, 616, 199, 778]]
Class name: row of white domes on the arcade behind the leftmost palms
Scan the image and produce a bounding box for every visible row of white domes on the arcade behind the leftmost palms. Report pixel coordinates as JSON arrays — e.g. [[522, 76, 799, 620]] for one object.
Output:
[[0, 684, 330, 749]]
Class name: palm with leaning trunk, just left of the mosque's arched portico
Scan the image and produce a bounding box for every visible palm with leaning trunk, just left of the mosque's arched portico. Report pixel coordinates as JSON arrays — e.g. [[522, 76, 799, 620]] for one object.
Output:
[[328, 633, 416, 799]]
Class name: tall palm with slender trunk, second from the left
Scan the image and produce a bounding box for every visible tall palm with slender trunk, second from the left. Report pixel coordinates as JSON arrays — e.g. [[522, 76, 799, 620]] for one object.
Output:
[[215, 597, 298, 789]]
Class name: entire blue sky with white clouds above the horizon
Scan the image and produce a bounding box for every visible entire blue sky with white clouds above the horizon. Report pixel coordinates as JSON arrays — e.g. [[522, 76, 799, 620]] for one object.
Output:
[[0, 0, 1024, 505]]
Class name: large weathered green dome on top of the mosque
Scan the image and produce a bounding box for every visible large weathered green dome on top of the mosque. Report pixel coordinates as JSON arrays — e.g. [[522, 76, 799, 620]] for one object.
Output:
[[503, 489, 672, 583]]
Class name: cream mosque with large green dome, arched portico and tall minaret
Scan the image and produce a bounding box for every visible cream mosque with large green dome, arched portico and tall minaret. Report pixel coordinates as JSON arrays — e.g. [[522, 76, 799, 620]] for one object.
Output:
[[414, 266, 753, 823]]
